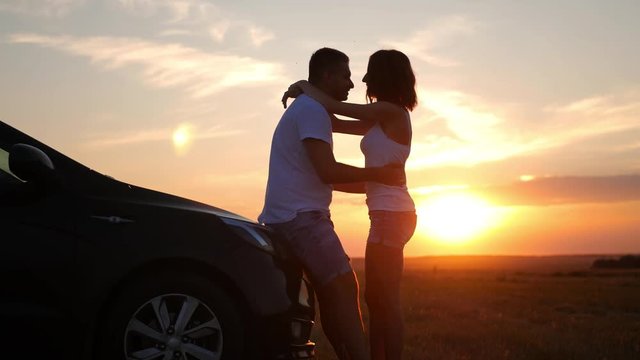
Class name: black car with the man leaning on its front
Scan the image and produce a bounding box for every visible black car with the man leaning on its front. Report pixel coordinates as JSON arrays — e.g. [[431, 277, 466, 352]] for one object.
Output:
[[0, 122, 315, 360]]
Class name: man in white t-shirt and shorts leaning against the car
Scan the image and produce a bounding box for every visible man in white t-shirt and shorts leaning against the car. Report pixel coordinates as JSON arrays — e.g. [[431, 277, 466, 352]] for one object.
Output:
[[258, 48, 405, 360]]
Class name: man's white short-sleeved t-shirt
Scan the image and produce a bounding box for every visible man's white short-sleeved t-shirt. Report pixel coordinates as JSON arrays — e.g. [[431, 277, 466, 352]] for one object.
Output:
[[258, 95, 333, 224]]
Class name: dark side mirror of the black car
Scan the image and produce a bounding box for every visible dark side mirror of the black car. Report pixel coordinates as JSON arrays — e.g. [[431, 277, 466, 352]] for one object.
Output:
[[9, 144, 55, 185]]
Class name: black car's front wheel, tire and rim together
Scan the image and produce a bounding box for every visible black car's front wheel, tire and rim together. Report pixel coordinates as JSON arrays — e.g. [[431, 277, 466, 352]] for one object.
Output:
[[97, 274, 247, 360]]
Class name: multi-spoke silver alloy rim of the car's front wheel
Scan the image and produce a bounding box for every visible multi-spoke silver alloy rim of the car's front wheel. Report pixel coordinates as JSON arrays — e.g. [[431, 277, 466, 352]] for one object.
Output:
[[124, 293, 223, 360]]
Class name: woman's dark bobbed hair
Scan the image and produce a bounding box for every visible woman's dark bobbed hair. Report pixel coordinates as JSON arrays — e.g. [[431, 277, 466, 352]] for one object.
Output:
[[366, 50, 418, 110]]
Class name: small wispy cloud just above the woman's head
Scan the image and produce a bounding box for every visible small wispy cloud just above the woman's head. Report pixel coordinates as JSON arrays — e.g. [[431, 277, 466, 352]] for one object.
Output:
[[381, 15, 478, 67]]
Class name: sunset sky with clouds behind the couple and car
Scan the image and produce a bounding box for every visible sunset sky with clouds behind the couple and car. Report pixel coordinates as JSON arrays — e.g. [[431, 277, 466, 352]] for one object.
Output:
[[0, 0, 640, 257]]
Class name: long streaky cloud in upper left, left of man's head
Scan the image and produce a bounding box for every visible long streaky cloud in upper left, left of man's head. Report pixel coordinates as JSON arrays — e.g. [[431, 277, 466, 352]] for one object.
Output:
[[10, 34, 282, 98]]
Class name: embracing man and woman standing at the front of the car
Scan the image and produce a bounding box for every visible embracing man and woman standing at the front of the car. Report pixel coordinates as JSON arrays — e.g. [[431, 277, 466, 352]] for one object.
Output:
[[259, 48, 417, 360]]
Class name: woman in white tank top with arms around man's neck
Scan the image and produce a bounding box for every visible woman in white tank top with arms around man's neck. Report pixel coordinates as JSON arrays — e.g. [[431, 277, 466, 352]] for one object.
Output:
[[283, 50, 417, 360]]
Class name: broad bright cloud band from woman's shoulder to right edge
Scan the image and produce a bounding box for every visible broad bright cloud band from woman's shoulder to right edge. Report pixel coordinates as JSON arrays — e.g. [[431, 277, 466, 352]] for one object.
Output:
[[407, 88, 640, 170]]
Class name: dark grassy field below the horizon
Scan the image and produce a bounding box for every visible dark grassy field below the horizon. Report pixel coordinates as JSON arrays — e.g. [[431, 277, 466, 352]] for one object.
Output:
[[312, 256, 640, 360]]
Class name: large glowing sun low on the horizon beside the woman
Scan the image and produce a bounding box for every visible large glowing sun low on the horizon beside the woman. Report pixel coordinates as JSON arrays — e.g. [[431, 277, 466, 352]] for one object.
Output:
[[417, 193, 497, 244]]
